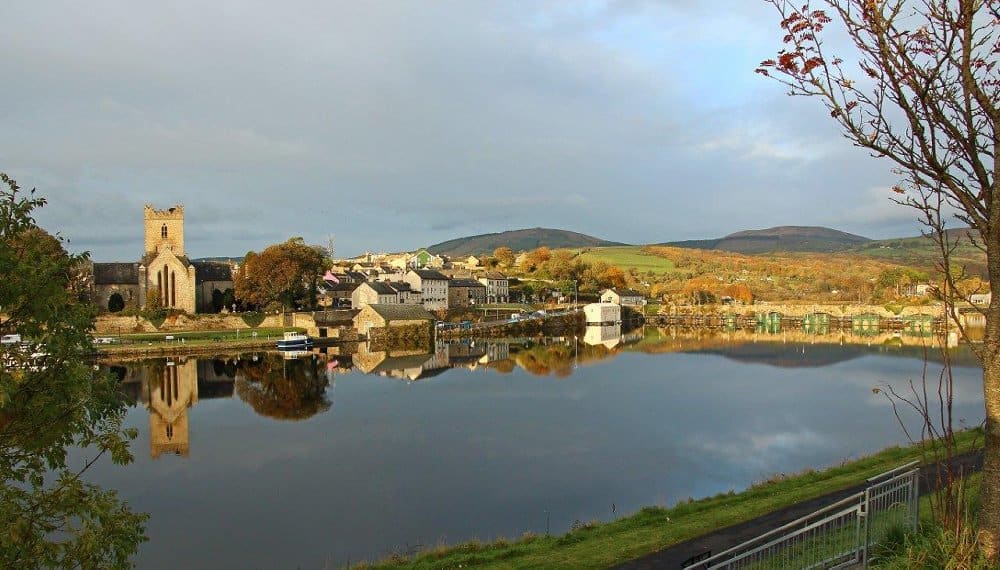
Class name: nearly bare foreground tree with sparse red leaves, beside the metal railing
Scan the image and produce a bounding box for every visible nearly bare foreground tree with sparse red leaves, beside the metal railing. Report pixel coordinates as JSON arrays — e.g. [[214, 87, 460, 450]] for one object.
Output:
[[757, 0, 1000, 563]]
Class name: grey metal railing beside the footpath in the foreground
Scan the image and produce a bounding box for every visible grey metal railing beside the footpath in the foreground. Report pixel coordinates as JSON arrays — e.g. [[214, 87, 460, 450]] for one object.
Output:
[[689, 462, 919, 570]]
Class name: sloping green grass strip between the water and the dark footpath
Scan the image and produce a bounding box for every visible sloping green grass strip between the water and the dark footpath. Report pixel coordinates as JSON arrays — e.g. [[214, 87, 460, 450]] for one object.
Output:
[[358, 430, 983, 568]]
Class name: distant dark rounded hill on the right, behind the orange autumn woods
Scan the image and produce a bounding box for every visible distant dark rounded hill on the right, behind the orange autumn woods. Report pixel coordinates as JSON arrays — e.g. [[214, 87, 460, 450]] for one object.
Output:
[[662, 226, 871, 254]]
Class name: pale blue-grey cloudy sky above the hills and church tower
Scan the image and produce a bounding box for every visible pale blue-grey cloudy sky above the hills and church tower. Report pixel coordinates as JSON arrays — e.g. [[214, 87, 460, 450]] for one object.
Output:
[[0, 0, 919, 261]]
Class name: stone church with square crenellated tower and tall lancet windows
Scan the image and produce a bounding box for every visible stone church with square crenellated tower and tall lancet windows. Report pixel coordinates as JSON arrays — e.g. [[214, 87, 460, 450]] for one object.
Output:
[[93, 204, 233, 313]]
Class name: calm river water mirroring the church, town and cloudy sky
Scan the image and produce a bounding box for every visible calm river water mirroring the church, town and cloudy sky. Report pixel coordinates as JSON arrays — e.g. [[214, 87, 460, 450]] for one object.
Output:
[[90, 328, 983, 568]]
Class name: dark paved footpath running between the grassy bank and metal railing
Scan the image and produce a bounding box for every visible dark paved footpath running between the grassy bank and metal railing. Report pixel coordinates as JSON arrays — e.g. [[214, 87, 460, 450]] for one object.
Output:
[[617, 450, 983, 570]]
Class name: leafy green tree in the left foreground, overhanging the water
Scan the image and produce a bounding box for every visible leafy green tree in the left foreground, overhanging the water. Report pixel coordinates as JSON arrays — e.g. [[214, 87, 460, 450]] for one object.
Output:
[[0, 173, 147, 568]]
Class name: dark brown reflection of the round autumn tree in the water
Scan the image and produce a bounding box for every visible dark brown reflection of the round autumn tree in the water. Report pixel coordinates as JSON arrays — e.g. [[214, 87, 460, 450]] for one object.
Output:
[[236, 354, 330, 420]]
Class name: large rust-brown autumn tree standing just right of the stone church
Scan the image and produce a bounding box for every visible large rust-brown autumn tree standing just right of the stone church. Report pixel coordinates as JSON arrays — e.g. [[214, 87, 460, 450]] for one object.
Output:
[[233, 238, 325, 308]]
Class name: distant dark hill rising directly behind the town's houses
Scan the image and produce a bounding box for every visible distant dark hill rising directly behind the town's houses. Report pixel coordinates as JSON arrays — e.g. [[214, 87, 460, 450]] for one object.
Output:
[[427, 228, 627, 257]]
